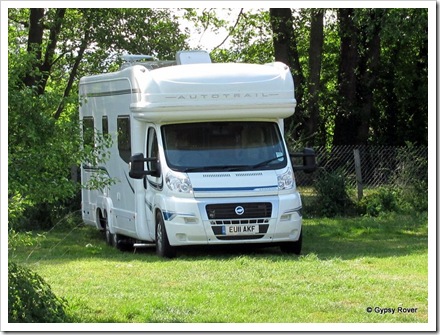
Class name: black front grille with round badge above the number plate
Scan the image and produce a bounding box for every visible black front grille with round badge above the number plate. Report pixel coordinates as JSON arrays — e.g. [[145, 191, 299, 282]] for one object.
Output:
[[206, 202, 272, 223]]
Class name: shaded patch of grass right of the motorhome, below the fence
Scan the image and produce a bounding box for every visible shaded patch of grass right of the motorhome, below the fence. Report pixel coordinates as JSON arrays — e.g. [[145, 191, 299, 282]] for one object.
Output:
[[303, 214, 428, 259]]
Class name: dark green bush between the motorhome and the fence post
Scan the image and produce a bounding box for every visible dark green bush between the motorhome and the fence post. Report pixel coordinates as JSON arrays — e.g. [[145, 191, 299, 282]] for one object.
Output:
[[314, 171, 353, 217]]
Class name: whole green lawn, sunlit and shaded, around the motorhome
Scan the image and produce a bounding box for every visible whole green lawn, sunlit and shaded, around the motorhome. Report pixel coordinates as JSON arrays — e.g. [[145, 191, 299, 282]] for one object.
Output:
[[10, 214, 428, 323]]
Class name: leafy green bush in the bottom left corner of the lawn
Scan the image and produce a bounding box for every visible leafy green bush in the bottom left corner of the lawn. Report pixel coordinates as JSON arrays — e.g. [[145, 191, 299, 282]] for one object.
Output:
[[8, 262, 69, 323]]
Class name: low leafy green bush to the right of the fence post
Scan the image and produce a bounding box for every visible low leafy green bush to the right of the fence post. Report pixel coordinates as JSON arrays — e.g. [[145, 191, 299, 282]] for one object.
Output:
[[358, 187, 399, 216]]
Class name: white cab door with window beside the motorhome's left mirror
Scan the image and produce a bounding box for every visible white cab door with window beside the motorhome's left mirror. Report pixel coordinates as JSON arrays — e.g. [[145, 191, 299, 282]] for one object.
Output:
[[145, 126, 163, 240]]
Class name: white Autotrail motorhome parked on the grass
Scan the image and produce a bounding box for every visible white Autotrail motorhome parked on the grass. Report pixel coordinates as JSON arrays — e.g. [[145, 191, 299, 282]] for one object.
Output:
[[79, 51, 315, 257]]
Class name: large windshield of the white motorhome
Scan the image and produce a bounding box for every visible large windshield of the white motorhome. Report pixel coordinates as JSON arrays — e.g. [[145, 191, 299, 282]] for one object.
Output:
[[162, 122, 287, 172]]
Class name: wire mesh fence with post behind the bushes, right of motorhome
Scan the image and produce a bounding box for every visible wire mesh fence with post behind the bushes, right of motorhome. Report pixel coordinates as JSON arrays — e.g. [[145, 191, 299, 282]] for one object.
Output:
[[291, 145, 428, 193]]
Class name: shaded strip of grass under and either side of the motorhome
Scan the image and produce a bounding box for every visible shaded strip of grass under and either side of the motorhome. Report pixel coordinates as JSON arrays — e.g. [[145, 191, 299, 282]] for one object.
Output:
[[10, 214, 428, 264]]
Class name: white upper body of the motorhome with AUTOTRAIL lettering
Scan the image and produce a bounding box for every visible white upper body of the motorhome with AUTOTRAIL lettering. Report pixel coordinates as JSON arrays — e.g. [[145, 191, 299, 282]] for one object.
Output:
[[80, 55, 296, 122]]
